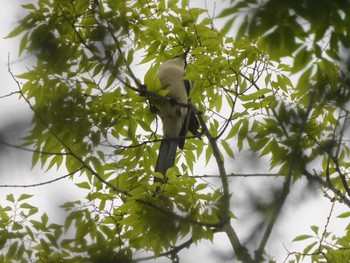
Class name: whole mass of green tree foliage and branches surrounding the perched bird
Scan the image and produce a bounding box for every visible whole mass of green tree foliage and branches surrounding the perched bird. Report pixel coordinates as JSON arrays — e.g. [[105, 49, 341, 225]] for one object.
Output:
[[1, 0, 350, 262]]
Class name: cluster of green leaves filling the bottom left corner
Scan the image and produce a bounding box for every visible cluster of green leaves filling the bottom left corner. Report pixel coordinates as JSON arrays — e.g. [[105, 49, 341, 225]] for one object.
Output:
[[0, 194, 130, 262]]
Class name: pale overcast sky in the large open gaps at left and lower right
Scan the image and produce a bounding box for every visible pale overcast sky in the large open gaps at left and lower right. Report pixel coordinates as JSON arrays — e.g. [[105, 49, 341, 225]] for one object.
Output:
[[0, 0, 345, 263]]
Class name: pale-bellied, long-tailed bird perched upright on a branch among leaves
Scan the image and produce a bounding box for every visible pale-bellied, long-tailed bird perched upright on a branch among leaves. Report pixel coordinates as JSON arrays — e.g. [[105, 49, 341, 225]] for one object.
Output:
[[154, 50, 200, 183]]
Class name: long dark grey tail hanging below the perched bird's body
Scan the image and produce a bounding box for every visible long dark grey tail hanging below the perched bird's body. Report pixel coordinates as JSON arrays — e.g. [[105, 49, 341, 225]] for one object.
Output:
[[154, 139, 179, 183]]
